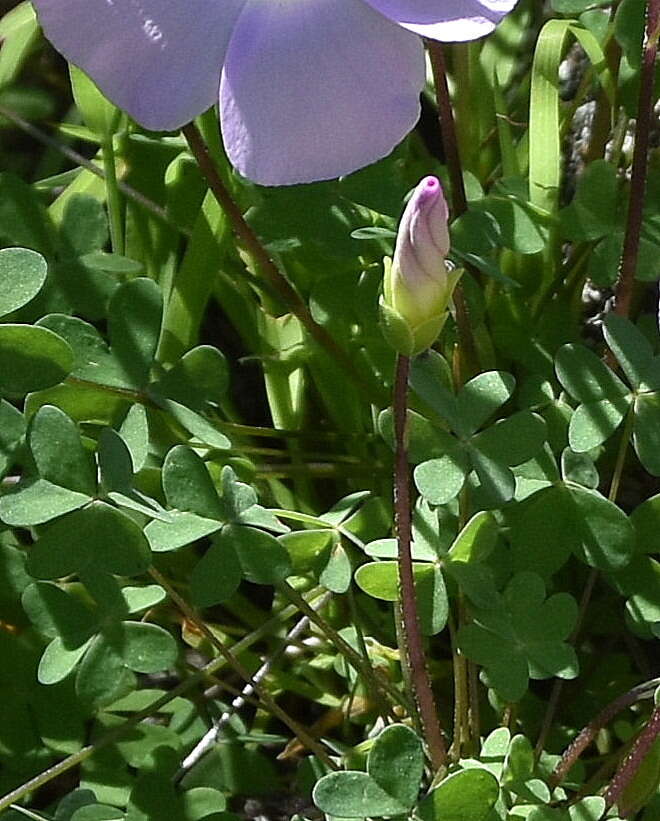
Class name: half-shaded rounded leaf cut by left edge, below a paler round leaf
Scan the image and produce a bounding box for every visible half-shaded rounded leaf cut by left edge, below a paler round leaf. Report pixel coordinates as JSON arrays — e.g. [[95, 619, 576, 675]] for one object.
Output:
[[0, 324, 73, 396]]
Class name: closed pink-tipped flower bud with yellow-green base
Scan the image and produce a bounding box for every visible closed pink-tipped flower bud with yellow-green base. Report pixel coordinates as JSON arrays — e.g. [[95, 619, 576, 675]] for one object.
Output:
[[380, 177, 462, 356]]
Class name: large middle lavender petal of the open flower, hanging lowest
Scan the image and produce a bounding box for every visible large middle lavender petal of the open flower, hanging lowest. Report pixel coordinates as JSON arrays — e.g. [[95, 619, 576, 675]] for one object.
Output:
[[220, 0, 424, 185]]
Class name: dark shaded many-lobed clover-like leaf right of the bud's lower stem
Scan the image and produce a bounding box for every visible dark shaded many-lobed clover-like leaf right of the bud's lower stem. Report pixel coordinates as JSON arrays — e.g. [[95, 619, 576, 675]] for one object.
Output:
[[458, 572, 578, 701]]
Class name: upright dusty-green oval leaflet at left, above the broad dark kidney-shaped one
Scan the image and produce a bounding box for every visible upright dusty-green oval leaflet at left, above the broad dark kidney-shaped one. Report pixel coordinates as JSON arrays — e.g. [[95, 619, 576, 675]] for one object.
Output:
[[28, 405, 96, 497]]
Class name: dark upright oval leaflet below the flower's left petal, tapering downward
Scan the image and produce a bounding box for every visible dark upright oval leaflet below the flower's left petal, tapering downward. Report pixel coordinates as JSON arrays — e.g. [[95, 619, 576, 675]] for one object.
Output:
[[108, 277, 163, 388]]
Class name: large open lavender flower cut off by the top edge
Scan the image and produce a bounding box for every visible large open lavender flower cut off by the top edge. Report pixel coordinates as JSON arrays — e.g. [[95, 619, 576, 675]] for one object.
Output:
[[34, 0, 517, 185]]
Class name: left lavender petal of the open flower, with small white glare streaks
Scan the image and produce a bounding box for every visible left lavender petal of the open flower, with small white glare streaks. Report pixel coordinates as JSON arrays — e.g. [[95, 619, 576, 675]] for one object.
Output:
[[34, 0, 245, 131]]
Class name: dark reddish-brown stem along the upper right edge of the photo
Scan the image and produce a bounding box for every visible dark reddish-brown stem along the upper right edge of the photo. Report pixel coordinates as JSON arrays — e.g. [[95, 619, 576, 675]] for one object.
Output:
[[614, 0, 660, 316]]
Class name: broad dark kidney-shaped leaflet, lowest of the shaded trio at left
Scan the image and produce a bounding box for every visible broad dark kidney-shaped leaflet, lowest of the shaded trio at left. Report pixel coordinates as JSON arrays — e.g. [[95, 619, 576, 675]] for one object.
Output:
[[28, 502, 151, 579]]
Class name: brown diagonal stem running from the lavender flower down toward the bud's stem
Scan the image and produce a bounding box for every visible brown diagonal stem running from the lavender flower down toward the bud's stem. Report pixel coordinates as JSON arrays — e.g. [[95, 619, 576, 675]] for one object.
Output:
[[181, 123, 383, 401]]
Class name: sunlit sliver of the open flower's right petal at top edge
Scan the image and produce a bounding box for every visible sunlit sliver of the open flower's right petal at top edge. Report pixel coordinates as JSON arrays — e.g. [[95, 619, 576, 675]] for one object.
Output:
[[364, 0, 518, 42]]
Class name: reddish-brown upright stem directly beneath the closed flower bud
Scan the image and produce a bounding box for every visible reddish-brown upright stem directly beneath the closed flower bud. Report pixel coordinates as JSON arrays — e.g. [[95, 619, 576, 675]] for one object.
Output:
[[394, 356, 447, 771]]
